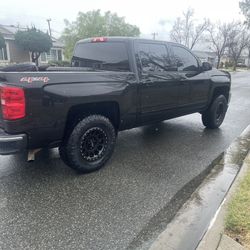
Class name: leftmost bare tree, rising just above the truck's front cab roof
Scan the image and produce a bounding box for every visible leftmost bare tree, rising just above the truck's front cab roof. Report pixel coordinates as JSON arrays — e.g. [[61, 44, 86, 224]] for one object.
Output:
[[170, 9, 210, 49]]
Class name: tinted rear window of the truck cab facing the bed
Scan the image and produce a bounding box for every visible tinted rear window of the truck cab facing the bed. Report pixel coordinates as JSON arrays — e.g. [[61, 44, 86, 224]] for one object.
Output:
[[72, 42, 130, 71]]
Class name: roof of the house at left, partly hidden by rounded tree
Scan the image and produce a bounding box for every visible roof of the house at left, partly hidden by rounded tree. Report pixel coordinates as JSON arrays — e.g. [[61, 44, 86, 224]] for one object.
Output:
[[0, 24, 64, 48]]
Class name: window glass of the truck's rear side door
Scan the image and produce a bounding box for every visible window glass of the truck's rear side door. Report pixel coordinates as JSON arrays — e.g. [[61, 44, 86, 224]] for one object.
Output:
[[138, 43, 170, 72]]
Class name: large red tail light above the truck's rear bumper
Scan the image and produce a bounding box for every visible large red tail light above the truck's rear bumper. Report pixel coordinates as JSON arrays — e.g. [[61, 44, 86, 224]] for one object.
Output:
[[0, 86, 25, 120]]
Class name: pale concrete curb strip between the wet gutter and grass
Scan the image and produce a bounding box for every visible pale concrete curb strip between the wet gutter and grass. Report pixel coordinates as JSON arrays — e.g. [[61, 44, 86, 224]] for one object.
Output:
[[197, 153, 250, 250]]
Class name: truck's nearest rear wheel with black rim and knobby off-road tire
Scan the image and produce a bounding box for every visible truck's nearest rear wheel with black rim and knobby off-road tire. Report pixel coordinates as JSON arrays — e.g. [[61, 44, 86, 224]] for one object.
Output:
[[59, 115, 116, 173]]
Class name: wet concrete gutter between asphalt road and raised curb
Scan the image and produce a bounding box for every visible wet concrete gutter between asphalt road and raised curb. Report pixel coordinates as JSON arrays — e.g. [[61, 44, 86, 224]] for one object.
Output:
[[147, 125, 250, 250]]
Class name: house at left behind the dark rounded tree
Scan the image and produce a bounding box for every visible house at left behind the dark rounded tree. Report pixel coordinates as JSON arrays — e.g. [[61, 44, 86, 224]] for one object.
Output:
[[0, 24, 64, 65]]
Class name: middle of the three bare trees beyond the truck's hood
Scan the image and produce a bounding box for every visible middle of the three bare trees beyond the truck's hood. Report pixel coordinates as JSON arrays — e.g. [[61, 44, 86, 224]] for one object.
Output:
[[207, 22, 238, 68]]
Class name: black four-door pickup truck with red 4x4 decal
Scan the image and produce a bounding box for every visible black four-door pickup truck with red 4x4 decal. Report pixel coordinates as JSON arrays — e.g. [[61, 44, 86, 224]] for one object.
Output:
[[0, 37, 231, 172]]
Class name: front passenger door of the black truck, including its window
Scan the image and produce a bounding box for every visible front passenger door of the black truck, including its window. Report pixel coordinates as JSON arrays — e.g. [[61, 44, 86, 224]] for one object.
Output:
[[169, 44, 211, 109]]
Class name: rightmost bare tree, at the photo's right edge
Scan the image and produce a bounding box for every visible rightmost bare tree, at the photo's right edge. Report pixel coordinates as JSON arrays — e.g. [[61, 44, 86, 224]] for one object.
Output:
[[228, 23, 250, 70]]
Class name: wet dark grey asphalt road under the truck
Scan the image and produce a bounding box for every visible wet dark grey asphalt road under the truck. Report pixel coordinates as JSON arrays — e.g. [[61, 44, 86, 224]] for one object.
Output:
[[0, 72, 250, 249]]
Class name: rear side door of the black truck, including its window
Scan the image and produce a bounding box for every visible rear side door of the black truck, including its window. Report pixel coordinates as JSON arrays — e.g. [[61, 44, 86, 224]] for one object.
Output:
[[135, 41, 185, 123]]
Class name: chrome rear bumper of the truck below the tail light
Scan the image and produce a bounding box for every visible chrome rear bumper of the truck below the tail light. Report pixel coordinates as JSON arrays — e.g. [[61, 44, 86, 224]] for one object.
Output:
[[0, 129, 27, 155]]
